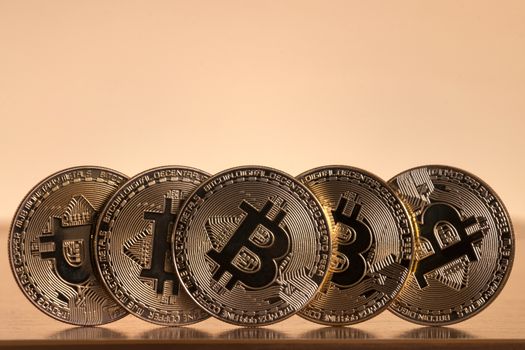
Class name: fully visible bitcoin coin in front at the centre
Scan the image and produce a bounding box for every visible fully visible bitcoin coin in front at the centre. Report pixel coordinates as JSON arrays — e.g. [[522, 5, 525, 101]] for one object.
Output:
[[173, 167, 331, 326]]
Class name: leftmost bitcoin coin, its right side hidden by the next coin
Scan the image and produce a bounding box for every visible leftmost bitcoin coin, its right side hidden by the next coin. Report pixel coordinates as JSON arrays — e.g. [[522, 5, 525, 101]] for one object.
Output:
[[9, 167, 127, 326]]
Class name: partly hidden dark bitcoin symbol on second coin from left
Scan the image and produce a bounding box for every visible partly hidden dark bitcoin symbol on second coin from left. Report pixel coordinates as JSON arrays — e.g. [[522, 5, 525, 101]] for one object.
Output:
[[140, 197, 179, 295]]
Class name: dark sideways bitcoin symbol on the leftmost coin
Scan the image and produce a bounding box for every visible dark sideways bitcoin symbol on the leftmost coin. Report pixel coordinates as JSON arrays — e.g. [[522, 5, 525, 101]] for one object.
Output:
[[37, 196, 95, 284]]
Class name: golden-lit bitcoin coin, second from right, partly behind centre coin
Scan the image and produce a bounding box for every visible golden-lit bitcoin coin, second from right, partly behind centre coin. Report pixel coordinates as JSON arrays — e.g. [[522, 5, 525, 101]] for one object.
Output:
[[298, 166, 415, 325]]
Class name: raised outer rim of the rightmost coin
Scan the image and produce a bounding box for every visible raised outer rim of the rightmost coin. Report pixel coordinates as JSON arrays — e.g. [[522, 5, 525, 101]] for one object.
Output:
[[387, 164, 516, 326]]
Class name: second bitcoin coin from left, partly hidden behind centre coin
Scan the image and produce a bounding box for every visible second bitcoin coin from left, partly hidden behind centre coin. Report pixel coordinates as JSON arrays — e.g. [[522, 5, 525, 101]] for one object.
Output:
[[94, 166, 209, 326]]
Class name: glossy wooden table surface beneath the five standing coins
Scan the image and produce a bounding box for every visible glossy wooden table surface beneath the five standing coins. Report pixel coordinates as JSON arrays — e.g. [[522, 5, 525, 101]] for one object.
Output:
[[0, 218, 525, 350]]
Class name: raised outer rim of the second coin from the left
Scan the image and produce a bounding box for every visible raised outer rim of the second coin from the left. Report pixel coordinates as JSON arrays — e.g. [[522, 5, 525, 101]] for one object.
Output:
[[91, 165, 211, 327]]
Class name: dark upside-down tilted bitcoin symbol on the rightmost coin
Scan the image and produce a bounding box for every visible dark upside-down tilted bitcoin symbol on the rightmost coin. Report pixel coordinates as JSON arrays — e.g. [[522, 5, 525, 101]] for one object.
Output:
[[414, 203, 483, 289]]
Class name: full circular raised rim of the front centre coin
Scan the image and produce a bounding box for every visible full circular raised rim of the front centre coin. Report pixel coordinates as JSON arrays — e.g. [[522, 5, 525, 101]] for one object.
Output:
[[171, 165, 332, 327]]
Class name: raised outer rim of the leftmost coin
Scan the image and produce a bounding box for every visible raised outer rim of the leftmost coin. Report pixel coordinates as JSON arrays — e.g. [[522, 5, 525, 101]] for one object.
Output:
[[7, 165, 128, 327]]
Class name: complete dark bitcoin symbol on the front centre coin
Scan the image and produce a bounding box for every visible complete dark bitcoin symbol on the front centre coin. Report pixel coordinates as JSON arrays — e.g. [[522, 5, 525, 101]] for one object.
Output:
[[206, 200, 290, 290]]
